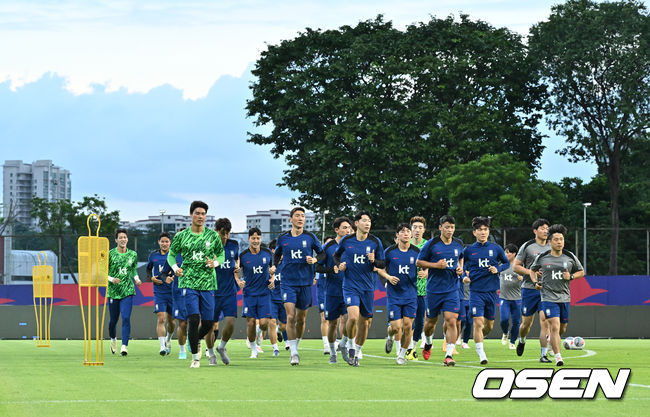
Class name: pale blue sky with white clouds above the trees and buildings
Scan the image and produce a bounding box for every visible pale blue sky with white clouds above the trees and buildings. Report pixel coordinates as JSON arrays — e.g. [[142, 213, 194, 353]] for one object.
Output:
[[0, 0, 608, 230]]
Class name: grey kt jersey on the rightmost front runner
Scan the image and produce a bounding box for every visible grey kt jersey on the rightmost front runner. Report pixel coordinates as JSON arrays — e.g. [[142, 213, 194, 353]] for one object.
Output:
[[531, 250, 583, 303]]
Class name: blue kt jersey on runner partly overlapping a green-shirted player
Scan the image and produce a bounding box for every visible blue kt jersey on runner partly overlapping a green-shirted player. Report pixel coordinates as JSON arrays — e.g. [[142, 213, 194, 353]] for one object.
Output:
[[385, 245, 420, 302]]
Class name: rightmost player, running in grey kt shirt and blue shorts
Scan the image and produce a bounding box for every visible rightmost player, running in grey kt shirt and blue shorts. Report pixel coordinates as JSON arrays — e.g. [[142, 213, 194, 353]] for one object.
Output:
[[530, 224, 585, 366]]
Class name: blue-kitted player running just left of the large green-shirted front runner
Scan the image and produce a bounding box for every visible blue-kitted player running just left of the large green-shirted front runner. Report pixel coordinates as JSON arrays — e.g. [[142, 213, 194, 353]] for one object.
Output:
[[147, 232, 176, 356]]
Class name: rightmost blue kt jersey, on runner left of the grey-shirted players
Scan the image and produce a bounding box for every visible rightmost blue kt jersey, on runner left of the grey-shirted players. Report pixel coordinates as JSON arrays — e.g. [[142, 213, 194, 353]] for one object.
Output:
[[463, 242, 510, 292]]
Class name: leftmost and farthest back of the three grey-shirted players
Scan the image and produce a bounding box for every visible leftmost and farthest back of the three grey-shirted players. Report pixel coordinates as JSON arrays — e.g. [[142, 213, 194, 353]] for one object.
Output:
[[499, 243, 523, 349]]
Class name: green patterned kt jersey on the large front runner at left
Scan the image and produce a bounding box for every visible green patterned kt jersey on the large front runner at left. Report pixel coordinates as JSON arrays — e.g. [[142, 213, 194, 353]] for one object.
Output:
[[167, 228, 225, 291]]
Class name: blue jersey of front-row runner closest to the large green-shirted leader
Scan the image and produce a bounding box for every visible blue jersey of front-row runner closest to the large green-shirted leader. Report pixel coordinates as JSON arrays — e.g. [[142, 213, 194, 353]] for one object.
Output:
[[273, 231, 323, 286]]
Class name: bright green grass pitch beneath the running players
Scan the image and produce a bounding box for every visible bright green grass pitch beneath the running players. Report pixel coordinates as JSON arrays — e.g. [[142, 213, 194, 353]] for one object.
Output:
[[0, 340, 650, 417]]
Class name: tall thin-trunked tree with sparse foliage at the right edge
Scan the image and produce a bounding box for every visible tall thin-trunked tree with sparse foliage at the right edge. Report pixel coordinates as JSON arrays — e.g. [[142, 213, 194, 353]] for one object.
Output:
[[529, 0, 650, 275]]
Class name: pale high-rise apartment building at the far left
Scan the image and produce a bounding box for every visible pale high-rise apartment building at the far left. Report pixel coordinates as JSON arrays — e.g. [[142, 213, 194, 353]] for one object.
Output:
[[2, 159, 72, 226]]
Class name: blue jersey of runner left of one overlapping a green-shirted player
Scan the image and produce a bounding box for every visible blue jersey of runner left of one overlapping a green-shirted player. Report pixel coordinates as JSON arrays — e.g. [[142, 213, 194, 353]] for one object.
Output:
[[334, 234, 385, 291]]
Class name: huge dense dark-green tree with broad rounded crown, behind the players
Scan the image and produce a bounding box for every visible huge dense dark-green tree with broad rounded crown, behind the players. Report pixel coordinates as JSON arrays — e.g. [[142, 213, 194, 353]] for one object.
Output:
[[247, 15, 545, 226]]
